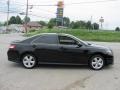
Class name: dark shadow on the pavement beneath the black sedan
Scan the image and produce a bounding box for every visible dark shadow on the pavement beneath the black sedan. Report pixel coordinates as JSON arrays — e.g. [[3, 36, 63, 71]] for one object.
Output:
[[10, 63, 113, 70]]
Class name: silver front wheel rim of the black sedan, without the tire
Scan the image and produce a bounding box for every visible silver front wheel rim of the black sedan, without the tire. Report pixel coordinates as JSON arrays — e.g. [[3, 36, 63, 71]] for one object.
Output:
[[92, 57, 104, 69]]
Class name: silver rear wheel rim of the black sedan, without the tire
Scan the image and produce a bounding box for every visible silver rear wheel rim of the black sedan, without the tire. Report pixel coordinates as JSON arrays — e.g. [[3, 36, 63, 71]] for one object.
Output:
[[23, 55, 36, 68]]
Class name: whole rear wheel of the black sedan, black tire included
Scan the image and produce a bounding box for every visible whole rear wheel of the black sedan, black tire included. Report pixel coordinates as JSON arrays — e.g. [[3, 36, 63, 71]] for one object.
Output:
[[22, 54, 37, 69]]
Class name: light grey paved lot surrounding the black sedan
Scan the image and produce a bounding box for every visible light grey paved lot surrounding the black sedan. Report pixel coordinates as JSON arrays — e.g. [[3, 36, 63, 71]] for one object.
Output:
[[0, 34, 120, 90]]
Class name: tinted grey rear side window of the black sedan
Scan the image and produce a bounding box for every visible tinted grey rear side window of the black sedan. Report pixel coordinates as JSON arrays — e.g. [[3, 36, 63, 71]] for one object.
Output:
[[32, 35, 58, 44]]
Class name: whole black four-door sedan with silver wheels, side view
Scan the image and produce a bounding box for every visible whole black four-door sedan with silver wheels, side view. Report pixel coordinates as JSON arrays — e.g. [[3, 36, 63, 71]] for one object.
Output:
[[7, 33, 114, 70]]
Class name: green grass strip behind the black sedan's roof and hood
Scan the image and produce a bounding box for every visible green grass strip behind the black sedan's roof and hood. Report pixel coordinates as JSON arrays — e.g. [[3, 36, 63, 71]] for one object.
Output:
[[25, 29, 120, 42]]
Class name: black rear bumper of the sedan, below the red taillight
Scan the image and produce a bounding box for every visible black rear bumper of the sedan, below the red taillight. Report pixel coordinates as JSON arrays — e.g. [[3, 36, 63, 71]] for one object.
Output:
[[7, 50, 20, 63]]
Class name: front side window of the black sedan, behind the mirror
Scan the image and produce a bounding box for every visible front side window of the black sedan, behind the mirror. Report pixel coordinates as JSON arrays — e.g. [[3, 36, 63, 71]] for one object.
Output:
[[59, 36, 77, 45]]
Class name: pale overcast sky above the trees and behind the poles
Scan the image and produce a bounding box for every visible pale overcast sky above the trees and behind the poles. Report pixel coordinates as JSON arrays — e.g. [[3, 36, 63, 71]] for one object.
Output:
[[0, 0, 120, 29]]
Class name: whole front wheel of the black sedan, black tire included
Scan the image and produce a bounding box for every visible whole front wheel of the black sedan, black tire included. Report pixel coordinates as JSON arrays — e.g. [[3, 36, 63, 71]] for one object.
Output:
[[89, 55, 105, 70]]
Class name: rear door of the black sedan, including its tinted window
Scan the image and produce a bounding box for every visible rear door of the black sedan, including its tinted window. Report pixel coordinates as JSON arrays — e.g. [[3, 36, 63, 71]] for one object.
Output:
[[32, 34, 59, 62]]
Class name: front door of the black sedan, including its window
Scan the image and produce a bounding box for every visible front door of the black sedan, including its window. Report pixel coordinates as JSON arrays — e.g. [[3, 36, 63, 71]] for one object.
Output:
[[59, 36, 88, 64]]
